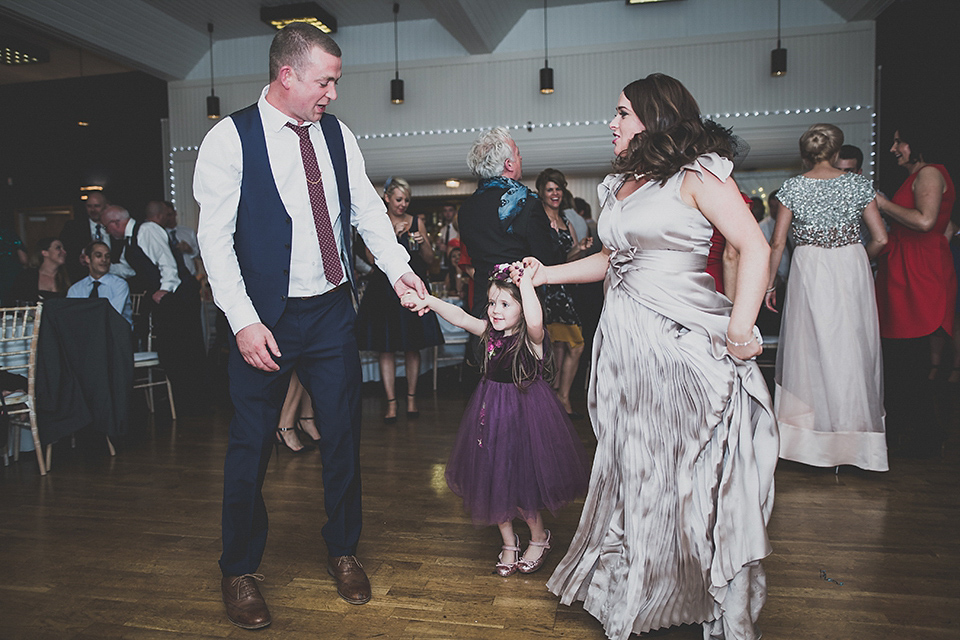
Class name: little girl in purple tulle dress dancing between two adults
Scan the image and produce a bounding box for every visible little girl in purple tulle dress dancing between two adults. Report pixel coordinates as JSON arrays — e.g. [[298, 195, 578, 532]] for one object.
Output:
[[403, 263, 589, 577]]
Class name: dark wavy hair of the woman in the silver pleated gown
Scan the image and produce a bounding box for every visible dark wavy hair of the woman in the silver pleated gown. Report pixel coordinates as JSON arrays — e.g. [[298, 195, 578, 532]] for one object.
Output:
[[613, 73, 733, 183]]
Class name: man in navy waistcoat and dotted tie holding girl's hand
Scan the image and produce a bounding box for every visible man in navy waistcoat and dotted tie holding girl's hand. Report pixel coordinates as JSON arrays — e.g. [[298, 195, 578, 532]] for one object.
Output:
[[194, 23, 425, 629]]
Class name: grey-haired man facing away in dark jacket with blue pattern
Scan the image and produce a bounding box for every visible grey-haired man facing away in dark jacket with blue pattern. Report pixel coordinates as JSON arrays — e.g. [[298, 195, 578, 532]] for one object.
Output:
[[459, 127, 564, 317]]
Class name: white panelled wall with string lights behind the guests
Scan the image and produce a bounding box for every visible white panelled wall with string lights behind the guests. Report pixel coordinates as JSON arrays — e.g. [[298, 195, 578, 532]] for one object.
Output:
[[169, 22, 874, 224]]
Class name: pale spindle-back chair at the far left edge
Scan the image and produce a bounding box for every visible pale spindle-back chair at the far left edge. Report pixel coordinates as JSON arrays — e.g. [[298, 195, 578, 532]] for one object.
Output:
[[0, 303, 47, 476]]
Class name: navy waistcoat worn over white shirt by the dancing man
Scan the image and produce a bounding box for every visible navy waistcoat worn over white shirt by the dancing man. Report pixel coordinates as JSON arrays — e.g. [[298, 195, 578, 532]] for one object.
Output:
[[230, 104, 356, 327]]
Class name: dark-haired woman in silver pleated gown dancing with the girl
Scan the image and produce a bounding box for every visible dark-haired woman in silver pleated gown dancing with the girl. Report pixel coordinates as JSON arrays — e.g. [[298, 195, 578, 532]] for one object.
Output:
[[527, 74, 778, 640]]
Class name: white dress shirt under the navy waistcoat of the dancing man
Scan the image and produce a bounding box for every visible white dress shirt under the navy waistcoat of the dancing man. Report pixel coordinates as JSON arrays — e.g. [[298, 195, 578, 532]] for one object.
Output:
[[193, 85, 410, 333]]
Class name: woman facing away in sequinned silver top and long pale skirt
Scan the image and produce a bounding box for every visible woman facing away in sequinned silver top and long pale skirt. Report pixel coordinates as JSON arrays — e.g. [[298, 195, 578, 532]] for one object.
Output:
[[766, 124, 888, 471]]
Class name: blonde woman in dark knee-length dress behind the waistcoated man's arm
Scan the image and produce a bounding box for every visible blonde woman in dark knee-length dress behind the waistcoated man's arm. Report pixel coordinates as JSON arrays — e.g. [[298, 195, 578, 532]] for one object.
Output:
[[357, 178, 443, 423]]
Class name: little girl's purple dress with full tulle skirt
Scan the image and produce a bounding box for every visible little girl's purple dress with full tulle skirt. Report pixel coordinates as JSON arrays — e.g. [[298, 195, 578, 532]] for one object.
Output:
[[446, 331, 590, 525]]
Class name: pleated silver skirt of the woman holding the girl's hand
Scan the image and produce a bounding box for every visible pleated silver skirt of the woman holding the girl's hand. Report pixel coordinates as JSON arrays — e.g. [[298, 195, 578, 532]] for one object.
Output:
[[547, 287, 777, 640]]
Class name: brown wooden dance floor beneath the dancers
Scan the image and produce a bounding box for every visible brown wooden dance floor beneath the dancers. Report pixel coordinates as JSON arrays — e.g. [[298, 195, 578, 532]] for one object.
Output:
[[0, 369, 960, 640]]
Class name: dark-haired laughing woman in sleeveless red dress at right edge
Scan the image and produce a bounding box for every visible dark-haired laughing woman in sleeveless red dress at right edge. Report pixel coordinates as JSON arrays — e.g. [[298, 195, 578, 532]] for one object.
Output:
[[877, 128, 957, 457]]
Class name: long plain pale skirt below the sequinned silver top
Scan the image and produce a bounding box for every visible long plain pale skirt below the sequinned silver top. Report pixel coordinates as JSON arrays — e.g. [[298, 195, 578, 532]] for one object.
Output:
[[774, 244, 888, 471]]
